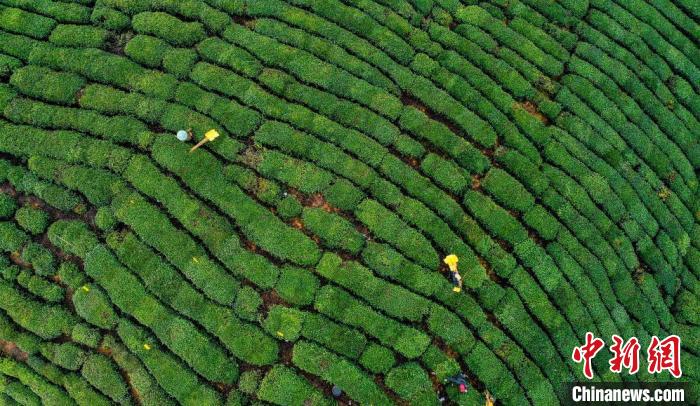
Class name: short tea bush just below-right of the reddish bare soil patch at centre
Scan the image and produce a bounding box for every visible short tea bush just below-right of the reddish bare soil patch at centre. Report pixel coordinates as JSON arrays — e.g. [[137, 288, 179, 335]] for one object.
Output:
[[301, 207, 365, 254]]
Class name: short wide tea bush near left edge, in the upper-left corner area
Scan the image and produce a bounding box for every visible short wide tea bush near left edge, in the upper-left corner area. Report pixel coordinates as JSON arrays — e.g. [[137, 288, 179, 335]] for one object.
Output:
[[10, 66, 85, 104]]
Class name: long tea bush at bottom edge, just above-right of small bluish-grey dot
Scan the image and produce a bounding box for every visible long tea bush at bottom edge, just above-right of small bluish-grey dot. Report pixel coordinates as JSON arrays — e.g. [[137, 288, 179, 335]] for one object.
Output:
[[292, 341, 390, 404]]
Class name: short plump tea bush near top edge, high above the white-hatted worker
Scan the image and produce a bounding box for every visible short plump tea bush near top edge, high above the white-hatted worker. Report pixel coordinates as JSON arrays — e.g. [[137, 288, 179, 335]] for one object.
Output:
[[131, 12, 206, 47]]
